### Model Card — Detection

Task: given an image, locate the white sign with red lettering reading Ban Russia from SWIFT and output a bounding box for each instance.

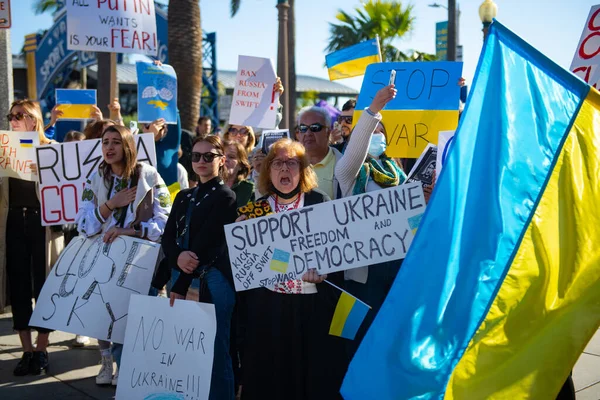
[229,56,279,129]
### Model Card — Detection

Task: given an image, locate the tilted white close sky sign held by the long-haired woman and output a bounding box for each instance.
[29,235,160,343]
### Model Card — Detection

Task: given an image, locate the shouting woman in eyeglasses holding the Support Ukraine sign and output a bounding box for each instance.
[239,139,347,400]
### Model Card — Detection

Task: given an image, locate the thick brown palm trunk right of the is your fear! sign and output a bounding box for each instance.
[168,0,202,131]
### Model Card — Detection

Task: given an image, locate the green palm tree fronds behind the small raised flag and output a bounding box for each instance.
[326,0,435,61]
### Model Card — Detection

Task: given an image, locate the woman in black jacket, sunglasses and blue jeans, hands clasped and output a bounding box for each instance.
[152,136,236,400]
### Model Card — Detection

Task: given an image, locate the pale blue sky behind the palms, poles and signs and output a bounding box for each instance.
[11,0,598,89]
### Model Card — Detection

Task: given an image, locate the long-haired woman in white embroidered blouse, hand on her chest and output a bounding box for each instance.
[76,125,171,385]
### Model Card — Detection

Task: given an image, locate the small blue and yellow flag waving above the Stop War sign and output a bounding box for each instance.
[325,38,381,81]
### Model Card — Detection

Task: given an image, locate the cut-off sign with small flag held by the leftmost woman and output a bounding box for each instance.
[0,131,40,181]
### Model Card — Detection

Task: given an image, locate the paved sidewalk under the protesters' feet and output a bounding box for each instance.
[0,314,600,400]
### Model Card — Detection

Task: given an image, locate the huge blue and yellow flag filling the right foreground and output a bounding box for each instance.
[342,22,600,400]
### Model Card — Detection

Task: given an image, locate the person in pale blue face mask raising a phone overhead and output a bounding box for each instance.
[335,85,406,356]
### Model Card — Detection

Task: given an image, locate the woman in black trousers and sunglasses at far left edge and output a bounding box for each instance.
[0,100,63,376]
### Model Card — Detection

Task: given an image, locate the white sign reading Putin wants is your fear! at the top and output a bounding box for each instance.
[66,0,158,56]
